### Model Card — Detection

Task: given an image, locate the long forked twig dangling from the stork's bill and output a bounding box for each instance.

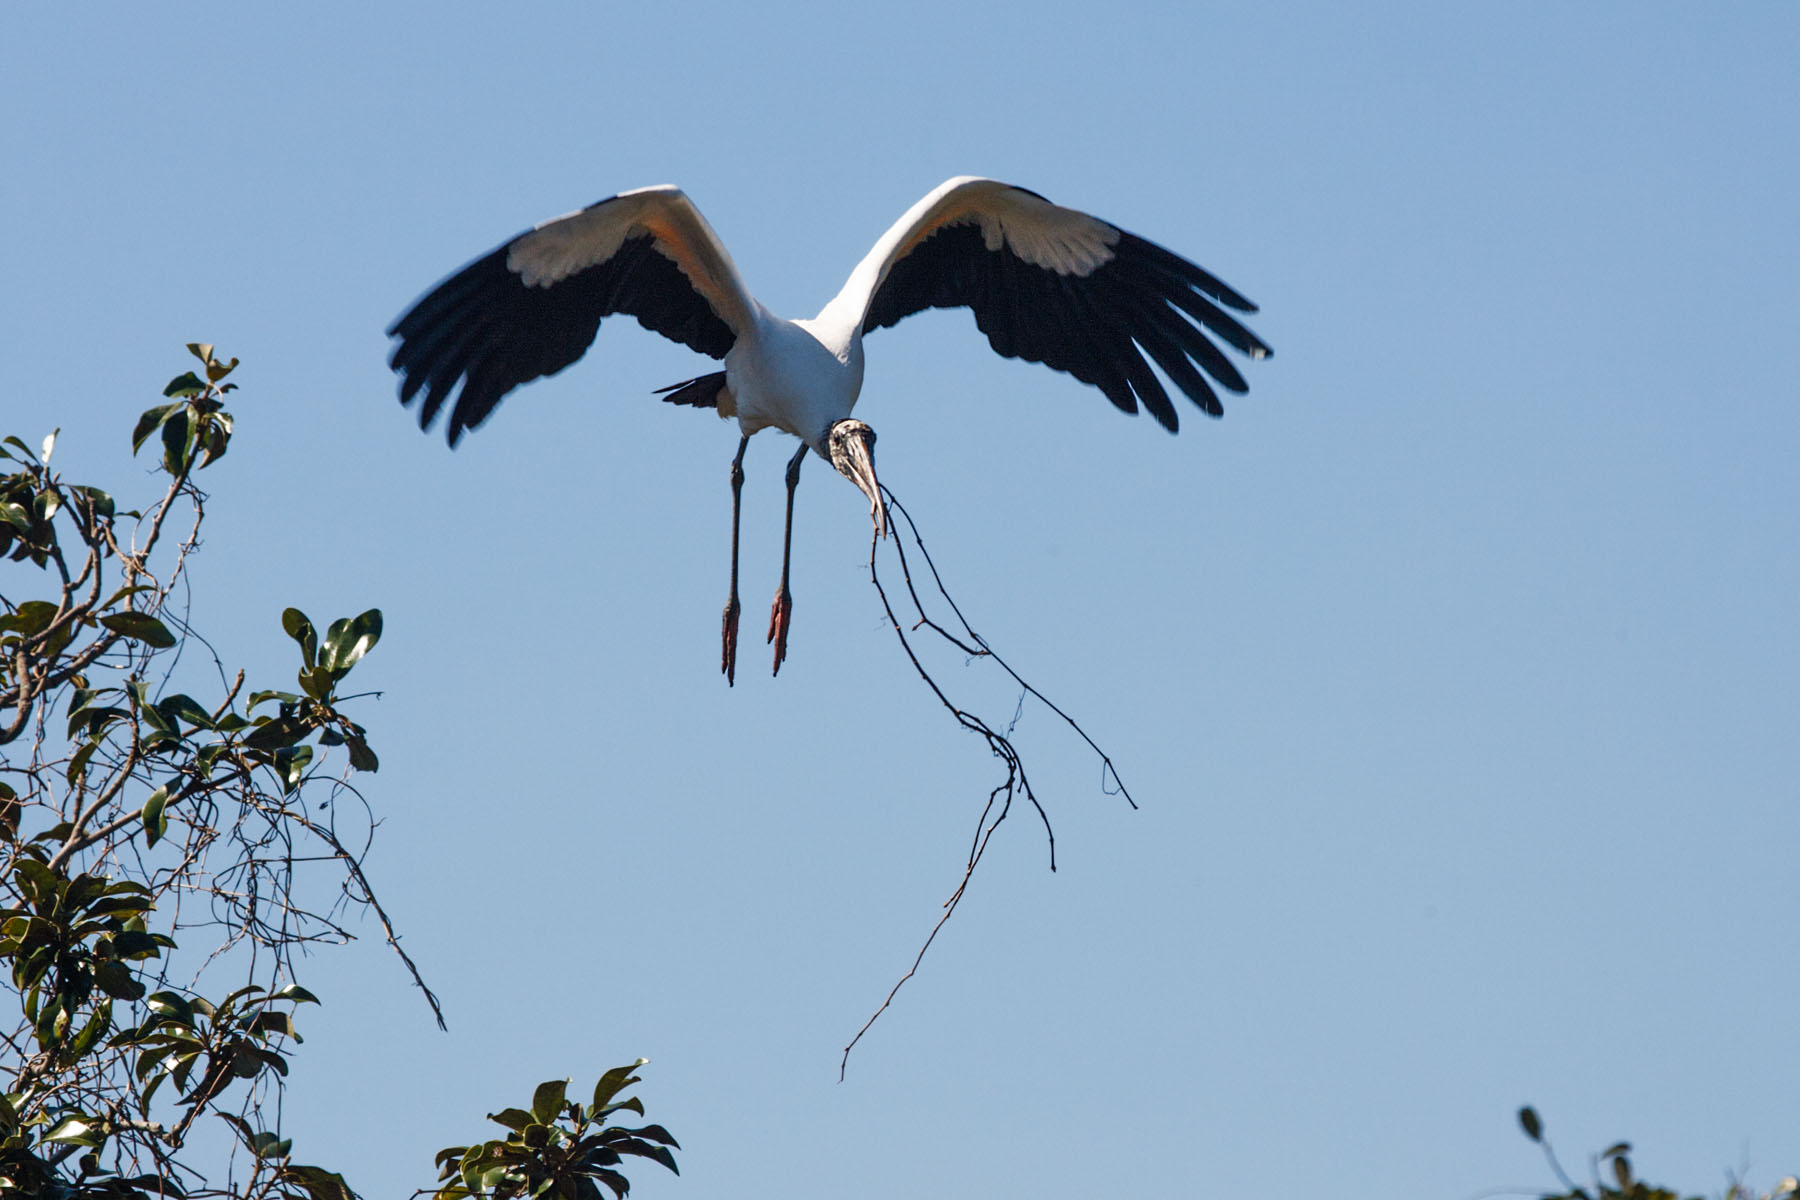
[837,486,1138,1083]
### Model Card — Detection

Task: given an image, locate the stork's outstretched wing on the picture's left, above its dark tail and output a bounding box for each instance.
[387,187,756,446]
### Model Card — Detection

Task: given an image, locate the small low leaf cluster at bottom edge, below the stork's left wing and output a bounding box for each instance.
[434,1058,680,1200]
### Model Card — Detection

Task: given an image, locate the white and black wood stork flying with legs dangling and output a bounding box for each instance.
[387,176,1269,684]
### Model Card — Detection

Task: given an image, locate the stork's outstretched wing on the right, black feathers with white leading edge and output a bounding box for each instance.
[832,176,1269,432]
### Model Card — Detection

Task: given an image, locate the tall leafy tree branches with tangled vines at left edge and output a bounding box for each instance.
[0,344,382,1200]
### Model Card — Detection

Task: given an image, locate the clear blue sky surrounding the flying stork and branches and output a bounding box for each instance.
[0,2,1800,1200]
